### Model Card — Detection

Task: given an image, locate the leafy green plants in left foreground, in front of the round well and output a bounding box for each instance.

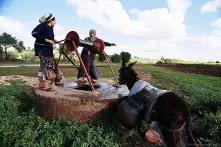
[0,81,147,147]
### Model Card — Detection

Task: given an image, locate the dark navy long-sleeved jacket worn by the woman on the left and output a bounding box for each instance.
[32,23,54,57]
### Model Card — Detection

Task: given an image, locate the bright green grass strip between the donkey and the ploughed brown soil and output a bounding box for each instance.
[144,66,221,105]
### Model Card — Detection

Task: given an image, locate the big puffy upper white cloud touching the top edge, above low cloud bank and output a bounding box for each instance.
[67,0,191,41]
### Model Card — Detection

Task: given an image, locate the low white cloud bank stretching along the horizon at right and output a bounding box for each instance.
[118,30,221,61]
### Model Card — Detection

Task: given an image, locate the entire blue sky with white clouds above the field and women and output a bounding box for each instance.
[0,0,221,61]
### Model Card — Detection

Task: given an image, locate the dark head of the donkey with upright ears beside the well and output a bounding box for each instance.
[119,62,140,90]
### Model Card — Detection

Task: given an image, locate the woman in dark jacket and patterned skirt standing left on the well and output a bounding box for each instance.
[32,13,61,90]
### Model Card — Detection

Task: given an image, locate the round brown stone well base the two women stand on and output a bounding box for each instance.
[34,80,129,123]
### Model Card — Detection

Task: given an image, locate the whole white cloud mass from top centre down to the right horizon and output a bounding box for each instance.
[65,0,221,60]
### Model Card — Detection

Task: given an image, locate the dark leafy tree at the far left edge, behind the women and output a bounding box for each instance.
[0,32,25,60]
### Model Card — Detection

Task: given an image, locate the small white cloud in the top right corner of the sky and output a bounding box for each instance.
[201,0,221,12]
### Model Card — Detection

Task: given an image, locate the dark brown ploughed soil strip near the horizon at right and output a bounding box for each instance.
[156,64,221,77]
